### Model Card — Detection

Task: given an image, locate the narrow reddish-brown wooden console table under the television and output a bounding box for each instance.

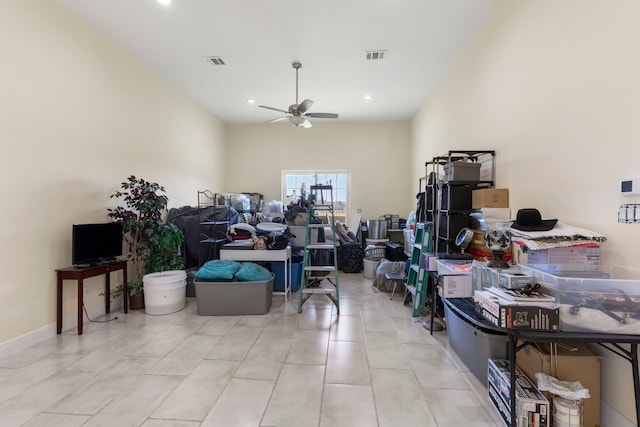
[56,261,129,335]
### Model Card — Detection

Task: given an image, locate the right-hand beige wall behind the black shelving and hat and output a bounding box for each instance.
[412,0,640,421]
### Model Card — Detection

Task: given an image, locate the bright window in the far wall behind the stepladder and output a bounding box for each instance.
[282,171,350,223]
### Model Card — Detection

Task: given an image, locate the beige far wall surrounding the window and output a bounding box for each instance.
[224,120,418,226]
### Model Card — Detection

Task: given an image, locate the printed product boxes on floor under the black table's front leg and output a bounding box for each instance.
[487,359,550,427]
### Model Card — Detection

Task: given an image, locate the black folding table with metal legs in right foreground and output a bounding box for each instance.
[446,298,640,426]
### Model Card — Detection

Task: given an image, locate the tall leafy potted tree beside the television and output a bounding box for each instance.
[108,175,184,310]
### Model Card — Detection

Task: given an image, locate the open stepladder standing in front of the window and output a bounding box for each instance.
[298,184,340,315]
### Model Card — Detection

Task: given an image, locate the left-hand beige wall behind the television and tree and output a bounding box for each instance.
[0,0,224,343]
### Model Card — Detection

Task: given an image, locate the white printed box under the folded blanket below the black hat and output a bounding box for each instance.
[511,244,600,271]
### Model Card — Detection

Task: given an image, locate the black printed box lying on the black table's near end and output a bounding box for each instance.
[473,291,560,331]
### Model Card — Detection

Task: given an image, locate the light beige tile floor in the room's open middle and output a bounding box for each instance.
[0,273,503,427]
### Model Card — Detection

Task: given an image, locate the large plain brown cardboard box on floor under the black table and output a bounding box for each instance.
[516,343,602,427]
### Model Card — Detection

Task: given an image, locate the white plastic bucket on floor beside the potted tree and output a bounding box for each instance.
[142,270,187,315]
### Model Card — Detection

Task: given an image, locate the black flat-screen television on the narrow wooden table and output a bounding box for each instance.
[71,222,122,266]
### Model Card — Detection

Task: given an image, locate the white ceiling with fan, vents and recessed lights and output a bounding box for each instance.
[58,0,496,123]
